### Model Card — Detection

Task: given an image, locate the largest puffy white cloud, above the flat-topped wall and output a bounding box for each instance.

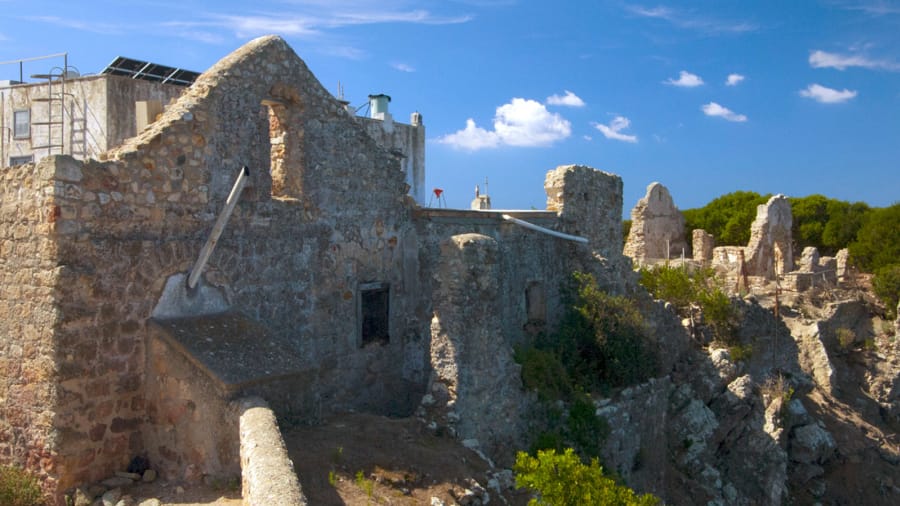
[437,98,572,151]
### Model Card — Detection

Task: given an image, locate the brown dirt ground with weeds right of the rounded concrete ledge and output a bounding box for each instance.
[284,414,529,506]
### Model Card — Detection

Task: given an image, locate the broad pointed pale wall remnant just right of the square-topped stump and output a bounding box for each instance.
[624,183,688,265]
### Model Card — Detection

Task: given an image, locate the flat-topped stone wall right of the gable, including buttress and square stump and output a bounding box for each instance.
[416,166,634,463]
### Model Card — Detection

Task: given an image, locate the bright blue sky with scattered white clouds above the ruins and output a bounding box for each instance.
[0,0,900,214]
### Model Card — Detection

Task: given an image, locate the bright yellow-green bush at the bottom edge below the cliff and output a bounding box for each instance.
[513,448,660,506]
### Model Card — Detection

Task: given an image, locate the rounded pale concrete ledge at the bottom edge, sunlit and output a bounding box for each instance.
[237,397,307,506]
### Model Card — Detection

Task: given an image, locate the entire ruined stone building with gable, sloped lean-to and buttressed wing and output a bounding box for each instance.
[0,36,630,498]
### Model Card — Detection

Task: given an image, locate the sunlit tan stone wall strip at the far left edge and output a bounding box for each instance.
[0,158,61,498]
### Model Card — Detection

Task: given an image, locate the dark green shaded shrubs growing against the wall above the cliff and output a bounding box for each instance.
[516,273,657,461]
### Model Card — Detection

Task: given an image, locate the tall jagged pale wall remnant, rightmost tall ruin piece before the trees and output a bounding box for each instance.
[746,195,794,279]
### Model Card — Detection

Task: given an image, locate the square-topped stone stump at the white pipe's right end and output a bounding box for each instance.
[544,165,622,258]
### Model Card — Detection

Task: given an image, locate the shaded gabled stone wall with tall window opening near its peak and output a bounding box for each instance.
[4,33,428,500]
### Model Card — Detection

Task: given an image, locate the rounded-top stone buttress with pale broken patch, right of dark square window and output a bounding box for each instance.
[431,234,527,460]
